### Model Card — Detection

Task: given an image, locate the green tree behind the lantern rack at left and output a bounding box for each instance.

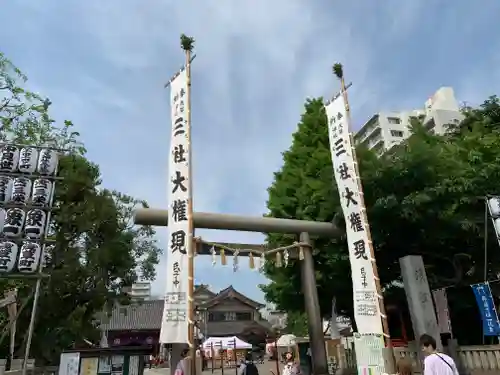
[0,53,161,364]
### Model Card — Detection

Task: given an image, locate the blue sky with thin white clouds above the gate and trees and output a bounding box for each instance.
[0,0,500,301]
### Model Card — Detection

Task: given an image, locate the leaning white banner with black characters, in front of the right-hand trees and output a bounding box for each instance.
[325,95,383,334]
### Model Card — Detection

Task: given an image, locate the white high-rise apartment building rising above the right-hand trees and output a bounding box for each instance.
[354,87,463,154]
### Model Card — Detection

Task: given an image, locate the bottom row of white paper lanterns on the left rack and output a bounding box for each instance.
[0,241,46,273]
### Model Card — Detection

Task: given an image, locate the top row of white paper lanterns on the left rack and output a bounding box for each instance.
[0,144,58,176]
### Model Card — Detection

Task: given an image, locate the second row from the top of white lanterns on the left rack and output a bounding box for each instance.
[0,176,53,207]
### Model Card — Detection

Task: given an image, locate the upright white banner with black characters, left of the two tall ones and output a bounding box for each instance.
[160,69,192,344]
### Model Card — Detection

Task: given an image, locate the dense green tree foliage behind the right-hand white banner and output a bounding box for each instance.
[262,97,500,344]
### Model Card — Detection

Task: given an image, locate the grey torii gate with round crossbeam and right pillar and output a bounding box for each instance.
[134,208,341,375]
